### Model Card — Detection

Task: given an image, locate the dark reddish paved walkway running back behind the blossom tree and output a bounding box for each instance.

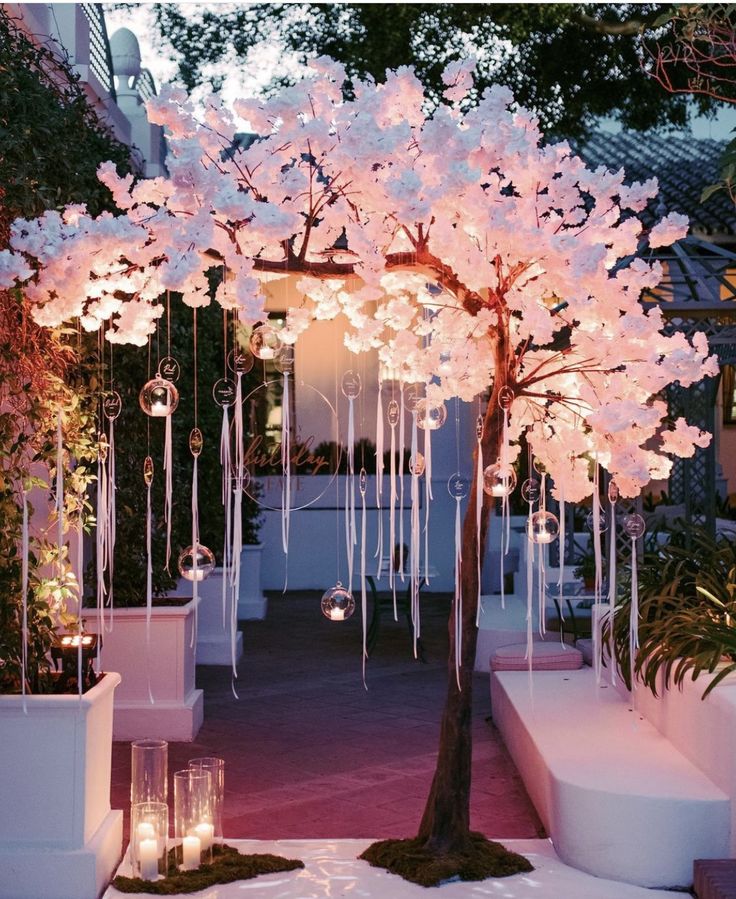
[112,593,543,840]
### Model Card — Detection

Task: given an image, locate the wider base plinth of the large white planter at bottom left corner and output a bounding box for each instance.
[0,811,123,899]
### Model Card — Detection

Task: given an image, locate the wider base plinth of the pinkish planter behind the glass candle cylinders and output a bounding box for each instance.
[113,690,204,743]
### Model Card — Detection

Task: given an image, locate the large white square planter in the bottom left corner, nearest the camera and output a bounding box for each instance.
[0,673,123,899]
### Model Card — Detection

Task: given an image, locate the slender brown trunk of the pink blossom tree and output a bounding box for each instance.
[418,338,508,854]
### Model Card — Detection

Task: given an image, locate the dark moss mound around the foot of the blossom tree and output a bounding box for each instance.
[360,833,534,887]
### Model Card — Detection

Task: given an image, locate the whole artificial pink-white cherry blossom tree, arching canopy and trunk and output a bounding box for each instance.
[0,59,717,884]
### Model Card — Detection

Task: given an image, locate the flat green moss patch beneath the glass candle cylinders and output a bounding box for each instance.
[112,846,304,896]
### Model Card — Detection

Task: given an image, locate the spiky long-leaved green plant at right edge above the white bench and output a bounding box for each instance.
[603,524,736,698]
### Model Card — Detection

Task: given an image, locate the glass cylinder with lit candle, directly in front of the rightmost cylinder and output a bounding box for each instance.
[174,768,214,871]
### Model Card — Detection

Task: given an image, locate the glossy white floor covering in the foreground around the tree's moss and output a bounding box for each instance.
[103,840,682,899]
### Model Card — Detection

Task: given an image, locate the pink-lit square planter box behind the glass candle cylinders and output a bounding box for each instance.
[85,599,204,742]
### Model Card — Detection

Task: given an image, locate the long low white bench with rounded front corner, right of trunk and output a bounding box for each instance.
[491,668,730,887]
